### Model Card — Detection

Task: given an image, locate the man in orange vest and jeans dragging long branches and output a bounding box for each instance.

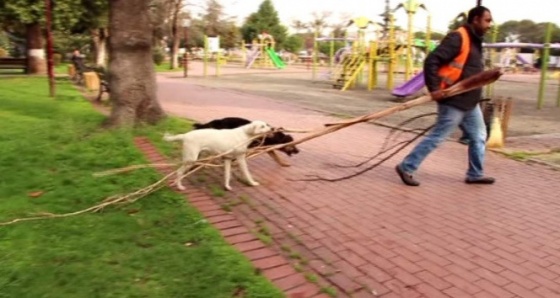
[396,6,494,186]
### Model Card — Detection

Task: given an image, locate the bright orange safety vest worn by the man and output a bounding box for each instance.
[438,27,471,89]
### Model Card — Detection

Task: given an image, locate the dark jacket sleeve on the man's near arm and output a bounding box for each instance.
[424,32,461,92]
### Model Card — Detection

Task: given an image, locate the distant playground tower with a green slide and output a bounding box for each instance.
[243,32,286,69]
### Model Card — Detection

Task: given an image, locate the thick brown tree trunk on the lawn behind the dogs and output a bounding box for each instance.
[107,0,165,126]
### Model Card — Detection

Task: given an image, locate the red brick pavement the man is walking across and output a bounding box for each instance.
[148,77,560,297]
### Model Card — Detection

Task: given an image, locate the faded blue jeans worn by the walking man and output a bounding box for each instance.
[400,104,486,179]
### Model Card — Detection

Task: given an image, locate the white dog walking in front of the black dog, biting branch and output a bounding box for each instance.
[163,121,272,190]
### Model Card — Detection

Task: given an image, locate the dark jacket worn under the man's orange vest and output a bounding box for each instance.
[424,25,484,111]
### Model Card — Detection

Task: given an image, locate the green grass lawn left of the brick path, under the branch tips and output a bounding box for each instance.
[0,77,283,298]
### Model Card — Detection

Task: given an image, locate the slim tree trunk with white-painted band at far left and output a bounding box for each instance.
[26,23,47,74]
